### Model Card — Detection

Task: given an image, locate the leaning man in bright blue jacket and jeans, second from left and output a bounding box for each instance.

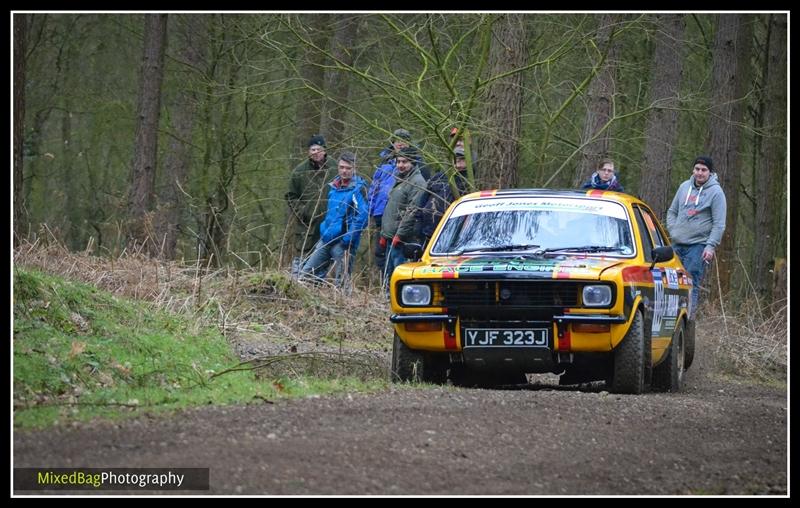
[302,151,367,287]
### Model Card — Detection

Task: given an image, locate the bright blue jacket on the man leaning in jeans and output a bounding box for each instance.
[319,175,369,252]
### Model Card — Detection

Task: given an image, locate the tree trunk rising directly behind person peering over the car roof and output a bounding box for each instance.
[572,14,618,187]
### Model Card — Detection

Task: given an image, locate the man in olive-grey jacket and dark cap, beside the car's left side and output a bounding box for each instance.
[376,146,426,288]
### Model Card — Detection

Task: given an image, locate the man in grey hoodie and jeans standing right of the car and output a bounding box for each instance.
[667,155,727,316]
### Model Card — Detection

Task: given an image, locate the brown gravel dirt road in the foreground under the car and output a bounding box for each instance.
[14,358,787,495]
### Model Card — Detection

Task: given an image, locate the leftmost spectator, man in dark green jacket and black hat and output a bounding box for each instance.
[285,134,336,273]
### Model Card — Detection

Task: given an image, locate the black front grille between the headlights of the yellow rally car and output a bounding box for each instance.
[440,280,583,309]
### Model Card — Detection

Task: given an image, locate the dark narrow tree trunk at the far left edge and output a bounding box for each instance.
[12,14,28,245]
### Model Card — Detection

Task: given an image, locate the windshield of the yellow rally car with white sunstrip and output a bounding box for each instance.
[431,197,634,256]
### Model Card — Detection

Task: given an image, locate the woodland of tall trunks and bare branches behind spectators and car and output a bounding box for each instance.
[12,12,788,308]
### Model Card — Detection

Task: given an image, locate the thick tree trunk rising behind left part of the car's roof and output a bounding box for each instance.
[478,14,527,189]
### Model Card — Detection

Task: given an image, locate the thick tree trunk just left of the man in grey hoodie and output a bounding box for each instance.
[639,14,686,221]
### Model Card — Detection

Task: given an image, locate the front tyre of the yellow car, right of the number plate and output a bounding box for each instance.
[609,311,650,393]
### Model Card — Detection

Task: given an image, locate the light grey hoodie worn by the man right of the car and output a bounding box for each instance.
[667,173,728,249]
